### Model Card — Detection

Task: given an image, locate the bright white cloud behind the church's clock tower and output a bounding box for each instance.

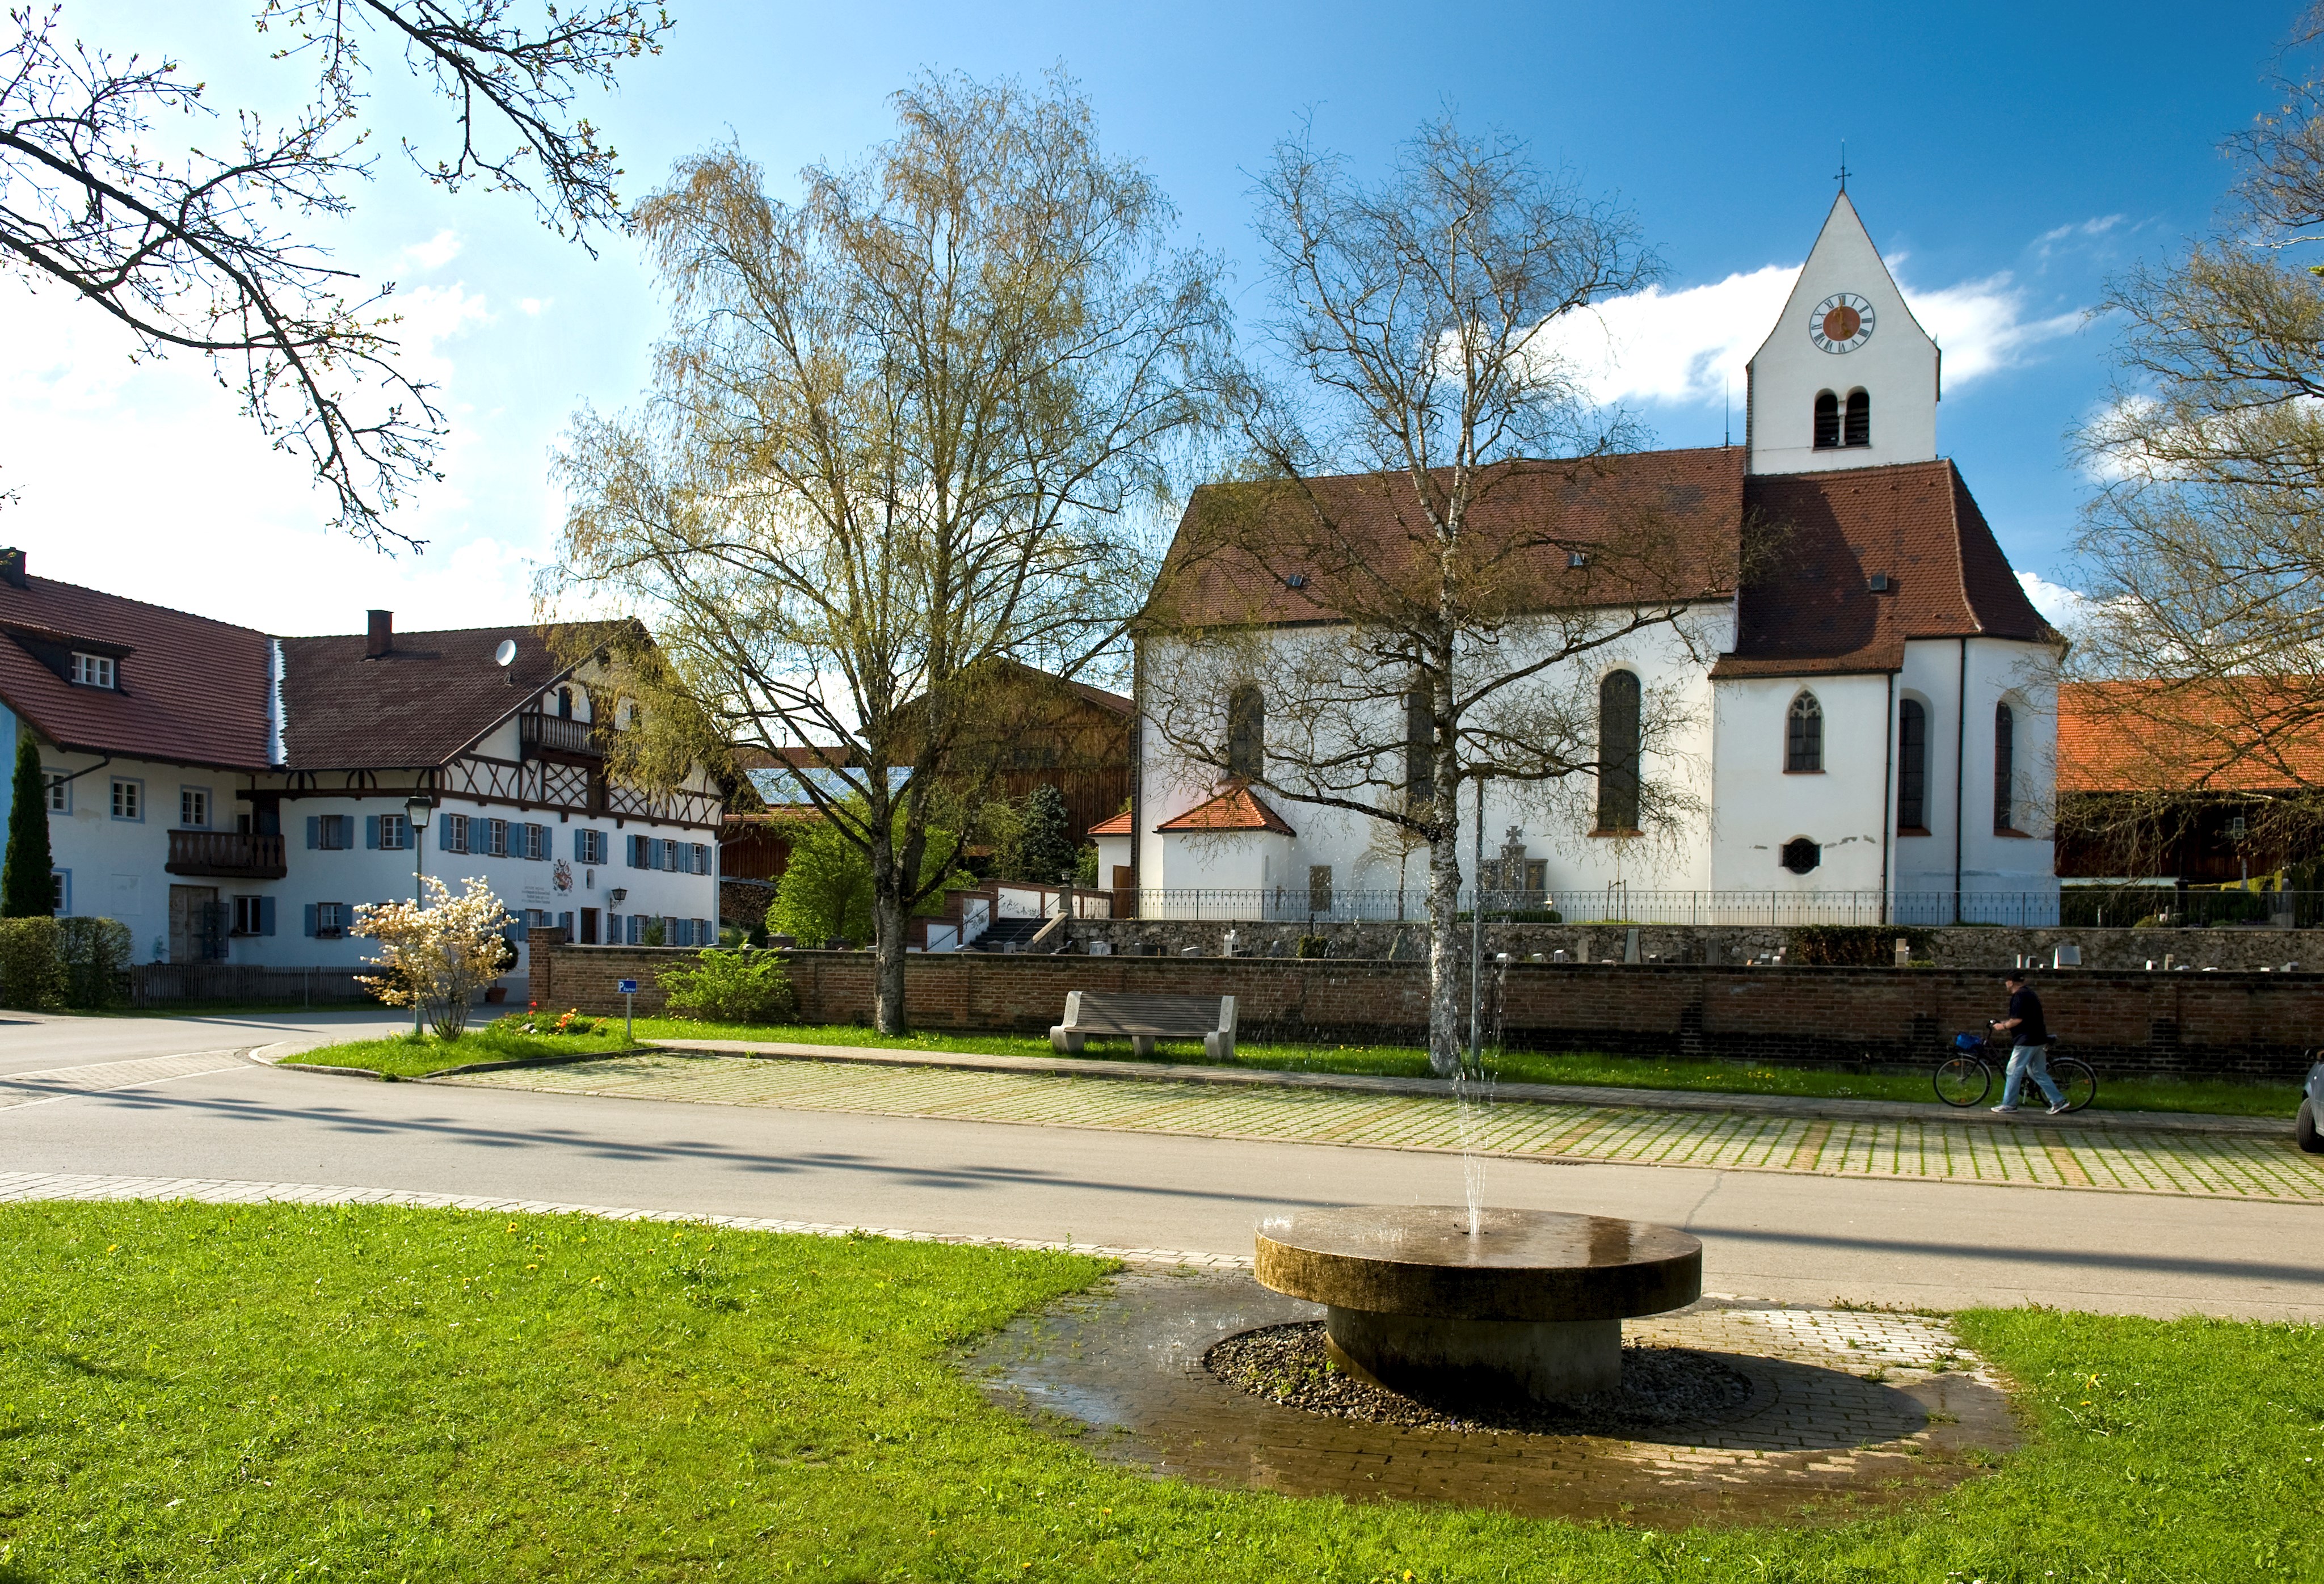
[1548,243,2082,406]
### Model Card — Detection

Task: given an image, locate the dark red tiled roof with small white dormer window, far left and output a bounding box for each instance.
[0,564,267,769]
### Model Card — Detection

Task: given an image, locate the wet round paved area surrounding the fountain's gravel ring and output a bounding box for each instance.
[967,1268,2017,1528]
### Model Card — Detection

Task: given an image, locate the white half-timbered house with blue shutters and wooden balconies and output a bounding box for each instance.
[0,550,721,975]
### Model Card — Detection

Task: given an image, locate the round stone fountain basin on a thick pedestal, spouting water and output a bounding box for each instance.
[1255,1206,1703,1405]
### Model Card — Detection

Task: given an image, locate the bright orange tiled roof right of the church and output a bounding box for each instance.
[2057,676,2324,792]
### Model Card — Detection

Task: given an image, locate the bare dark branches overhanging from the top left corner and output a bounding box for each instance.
[0,0,672,544]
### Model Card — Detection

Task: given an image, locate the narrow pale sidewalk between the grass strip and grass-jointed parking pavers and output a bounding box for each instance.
[646,1040,2298,1138]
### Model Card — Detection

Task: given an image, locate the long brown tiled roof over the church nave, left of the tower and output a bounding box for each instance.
[1153,446,1745,627]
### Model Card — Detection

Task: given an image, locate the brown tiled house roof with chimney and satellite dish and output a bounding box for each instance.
[279,627,572,771]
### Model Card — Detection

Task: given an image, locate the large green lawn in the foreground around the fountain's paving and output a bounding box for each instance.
[0,1203,2324,1584]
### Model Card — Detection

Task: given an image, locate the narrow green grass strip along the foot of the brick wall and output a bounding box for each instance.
[609,1017,2298,1119]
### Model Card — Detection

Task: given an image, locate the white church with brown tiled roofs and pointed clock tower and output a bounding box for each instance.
[1115,191,2059,924]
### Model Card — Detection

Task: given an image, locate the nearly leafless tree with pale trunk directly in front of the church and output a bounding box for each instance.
[1141,121,1736,1073]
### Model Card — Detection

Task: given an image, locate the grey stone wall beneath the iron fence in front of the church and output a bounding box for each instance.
[1069,920,2324,968]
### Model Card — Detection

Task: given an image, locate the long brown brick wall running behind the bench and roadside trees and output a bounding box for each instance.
[532,941,2324,1077]
